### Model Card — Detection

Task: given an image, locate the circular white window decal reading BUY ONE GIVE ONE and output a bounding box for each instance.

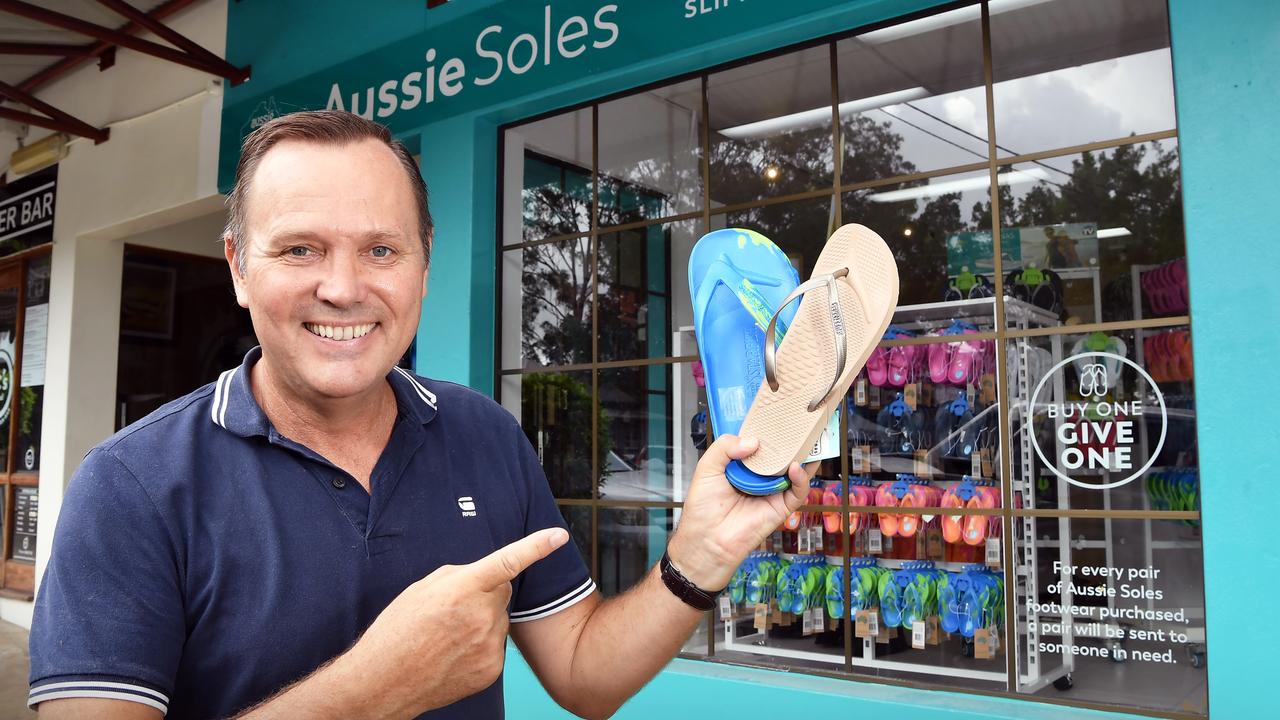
[1027,352,1169,489]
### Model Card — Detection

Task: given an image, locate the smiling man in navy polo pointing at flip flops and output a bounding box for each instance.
[29,111,809,719]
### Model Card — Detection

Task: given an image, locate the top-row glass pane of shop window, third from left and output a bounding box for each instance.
[707,45,835,209]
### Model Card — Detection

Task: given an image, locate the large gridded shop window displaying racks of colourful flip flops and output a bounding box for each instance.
[497,0,1207,716]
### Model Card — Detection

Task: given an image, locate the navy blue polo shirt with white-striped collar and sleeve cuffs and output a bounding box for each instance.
[28,348,595,719]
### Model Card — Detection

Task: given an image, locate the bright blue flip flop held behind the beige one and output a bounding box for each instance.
[689,228,800,495]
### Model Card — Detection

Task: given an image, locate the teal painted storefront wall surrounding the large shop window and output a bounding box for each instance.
[220,0,1280,720]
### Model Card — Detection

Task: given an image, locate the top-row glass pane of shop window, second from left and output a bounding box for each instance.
[599,79,703,227]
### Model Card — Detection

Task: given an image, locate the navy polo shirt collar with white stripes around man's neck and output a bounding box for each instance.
[210,346,436,437]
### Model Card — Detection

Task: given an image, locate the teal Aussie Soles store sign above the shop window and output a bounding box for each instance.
[219,0,933,190]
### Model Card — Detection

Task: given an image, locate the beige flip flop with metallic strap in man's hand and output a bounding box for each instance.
[739,224,897,477]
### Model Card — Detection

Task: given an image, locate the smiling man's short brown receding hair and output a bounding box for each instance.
[223,110,435,275]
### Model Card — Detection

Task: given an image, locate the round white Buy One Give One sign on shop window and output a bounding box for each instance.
[1028,352,1169,489]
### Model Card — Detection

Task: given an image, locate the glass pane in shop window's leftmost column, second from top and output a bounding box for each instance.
[502,237,593,369]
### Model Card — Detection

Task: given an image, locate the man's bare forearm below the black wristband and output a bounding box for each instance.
[572,566,705,716]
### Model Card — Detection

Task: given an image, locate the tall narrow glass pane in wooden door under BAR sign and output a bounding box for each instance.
[15,255,51,471]
